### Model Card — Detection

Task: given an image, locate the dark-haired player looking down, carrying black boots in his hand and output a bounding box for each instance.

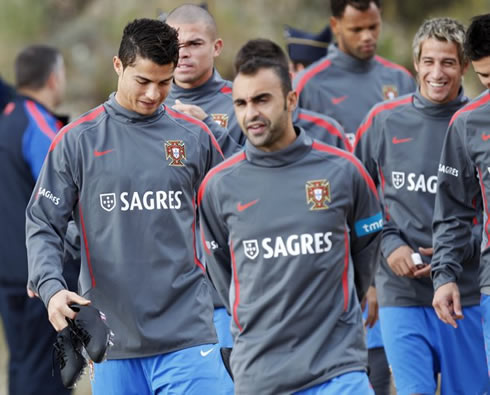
[26,19,228,395]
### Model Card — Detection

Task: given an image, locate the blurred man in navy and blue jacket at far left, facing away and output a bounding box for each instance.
[0,45,74,395]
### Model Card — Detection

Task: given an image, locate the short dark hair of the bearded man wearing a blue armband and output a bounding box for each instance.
[233,38,293,96]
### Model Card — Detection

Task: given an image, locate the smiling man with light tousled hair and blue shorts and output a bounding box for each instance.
[354,18,488,395]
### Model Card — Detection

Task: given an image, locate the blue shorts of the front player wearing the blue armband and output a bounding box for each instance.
[295,372,374,395]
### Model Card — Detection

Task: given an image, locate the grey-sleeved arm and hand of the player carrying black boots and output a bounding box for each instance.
[26,127,89,330]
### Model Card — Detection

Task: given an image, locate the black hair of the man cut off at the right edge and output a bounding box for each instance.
[464,14,490,60]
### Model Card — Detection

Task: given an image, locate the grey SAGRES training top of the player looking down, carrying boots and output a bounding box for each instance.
[26,94,222,359]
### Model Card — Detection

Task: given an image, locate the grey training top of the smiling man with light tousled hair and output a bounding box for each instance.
[354,91,479,306]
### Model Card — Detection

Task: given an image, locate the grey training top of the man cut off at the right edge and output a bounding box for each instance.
[432,90,490,294]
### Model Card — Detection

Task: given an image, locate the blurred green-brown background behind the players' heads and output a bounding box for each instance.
[0,0,490,117]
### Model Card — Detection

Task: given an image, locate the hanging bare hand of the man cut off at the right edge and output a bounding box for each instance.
[432,283,464,328]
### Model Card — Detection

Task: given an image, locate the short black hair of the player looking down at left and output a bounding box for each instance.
[118,18,179,68]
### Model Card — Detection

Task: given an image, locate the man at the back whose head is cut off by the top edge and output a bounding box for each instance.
[294,0,416,142]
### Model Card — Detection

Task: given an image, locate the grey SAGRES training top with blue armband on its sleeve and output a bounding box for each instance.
[198,129,383,395]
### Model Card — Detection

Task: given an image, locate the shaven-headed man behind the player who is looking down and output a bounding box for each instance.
[166,4,245,157]
